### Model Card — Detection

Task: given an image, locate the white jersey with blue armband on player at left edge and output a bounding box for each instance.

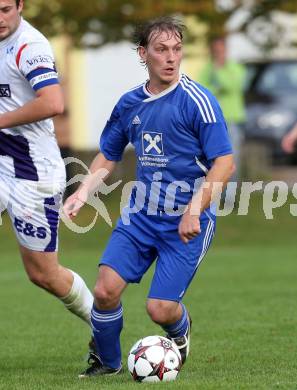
[0,19,65,181]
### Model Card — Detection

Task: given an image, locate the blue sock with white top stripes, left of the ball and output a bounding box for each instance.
[91,304,123,368]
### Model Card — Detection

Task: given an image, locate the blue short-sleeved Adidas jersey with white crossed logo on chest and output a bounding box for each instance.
[100,75,232,218]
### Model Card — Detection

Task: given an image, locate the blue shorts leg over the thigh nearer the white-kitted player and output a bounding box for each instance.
[99,228,157,283]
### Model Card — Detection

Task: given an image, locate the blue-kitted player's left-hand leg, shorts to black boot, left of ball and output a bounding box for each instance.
[80,222,156,377]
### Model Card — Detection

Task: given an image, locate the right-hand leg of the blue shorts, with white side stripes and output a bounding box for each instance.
[148,219,215,302]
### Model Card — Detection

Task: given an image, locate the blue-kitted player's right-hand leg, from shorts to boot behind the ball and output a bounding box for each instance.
[147,213,215,363]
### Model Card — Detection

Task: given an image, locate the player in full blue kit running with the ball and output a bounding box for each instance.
[64,17,234,377]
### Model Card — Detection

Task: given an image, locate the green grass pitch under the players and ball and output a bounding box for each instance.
[0,195,297,390]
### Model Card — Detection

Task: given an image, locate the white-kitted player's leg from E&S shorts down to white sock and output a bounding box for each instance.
[8,179,93,324]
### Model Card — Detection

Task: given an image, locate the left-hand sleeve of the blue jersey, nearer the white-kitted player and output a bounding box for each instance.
[100,106,129,161]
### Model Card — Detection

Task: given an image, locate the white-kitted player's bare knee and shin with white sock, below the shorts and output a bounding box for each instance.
[20,245,93,325]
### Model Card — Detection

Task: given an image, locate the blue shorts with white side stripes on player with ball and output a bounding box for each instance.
[100,212,215,302]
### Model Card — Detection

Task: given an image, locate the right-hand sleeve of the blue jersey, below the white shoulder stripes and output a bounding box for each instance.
[195,96,233,161]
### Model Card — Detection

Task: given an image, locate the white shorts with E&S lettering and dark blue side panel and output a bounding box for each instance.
[0,175,65,252]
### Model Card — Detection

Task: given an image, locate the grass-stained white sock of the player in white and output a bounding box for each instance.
[60,270,94,326]
